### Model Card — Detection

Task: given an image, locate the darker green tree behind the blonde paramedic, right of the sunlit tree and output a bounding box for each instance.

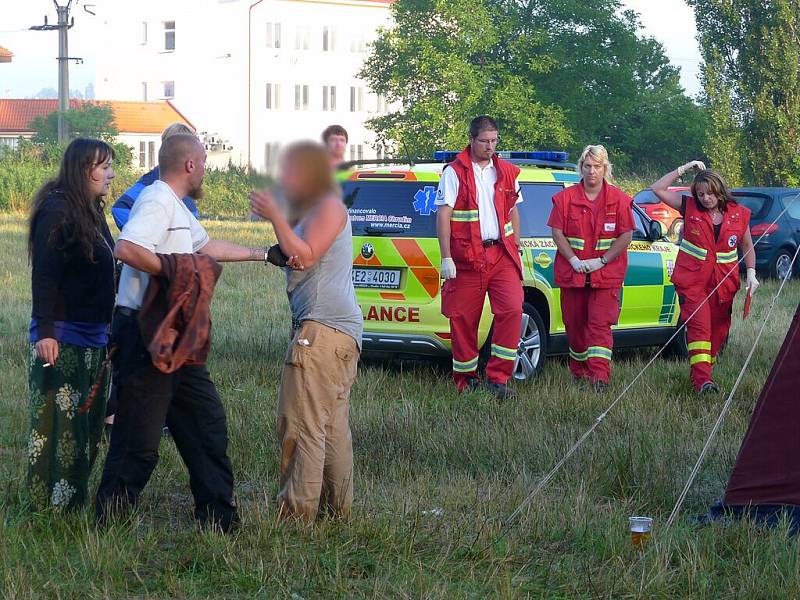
[517,0,707,171]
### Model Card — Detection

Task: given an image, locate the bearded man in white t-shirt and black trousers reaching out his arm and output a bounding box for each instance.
[96,134,266,531]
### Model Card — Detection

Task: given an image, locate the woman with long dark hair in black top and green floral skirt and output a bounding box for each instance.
[28,139,114,510]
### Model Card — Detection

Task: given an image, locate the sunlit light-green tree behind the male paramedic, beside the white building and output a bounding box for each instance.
[361,0,570,154]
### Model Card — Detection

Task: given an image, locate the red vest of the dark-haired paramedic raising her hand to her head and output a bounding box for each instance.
[672,196,750,302]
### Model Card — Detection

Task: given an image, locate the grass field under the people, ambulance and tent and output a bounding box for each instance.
[0,216,800,599]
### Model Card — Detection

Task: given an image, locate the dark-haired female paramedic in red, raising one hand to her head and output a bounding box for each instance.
[652,161,759,393]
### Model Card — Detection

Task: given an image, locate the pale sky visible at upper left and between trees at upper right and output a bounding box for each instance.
[0,0,700,98]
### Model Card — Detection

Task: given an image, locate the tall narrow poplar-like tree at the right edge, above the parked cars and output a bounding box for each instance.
[689,0,800,185]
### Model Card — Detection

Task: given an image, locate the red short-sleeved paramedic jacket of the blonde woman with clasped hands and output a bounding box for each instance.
[553,181,633,288]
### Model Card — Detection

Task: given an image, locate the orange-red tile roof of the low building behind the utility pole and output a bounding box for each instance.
[0,99,194,134]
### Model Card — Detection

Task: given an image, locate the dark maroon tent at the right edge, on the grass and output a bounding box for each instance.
[708,305,800,533]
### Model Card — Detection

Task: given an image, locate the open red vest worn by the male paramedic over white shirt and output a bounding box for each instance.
[446,147,522,279]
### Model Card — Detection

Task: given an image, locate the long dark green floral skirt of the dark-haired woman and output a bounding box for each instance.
[28,343,110,510]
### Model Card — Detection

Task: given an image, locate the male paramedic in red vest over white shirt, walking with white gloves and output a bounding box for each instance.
[436,115,523,399]
